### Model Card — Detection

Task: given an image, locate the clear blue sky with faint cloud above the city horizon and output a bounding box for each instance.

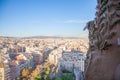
[0,0,97,37]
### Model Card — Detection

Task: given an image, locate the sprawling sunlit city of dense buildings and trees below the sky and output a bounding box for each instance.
[0,37,88,80]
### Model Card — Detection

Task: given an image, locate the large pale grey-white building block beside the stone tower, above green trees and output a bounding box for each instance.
[58,52,85,72]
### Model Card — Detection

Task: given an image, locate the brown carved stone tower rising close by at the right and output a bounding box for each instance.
[85,0,120,80]
